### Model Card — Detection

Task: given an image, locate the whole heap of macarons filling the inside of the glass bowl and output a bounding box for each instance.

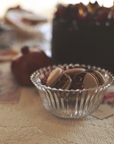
[46,68,105,90]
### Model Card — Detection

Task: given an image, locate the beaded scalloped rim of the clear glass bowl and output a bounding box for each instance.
[30,63,114,92]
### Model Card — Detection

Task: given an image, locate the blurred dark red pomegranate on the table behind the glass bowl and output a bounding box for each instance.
[11,46,52,86]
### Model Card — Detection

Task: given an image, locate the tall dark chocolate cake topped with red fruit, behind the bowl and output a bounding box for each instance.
[52,2,114,74]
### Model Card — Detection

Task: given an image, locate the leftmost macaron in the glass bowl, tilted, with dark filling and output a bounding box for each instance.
[46,68,72,89]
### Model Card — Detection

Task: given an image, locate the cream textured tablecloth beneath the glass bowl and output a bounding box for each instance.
[0,64,114,144]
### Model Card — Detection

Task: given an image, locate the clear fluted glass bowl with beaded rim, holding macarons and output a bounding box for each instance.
[30,64,113,118]
